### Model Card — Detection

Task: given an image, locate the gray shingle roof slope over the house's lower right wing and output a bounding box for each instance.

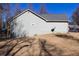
[40,14,67,22]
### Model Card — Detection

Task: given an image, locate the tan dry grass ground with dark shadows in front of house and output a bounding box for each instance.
[0,33,79,56]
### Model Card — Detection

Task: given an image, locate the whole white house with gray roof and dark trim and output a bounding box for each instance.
[11,10,68,37]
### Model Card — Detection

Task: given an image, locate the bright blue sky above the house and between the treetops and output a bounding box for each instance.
[11,3,79,19]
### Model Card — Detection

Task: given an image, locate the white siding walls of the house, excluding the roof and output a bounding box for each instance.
[12,11,68,37]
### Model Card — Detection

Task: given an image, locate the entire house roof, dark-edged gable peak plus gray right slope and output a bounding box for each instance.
[10,9,67,22]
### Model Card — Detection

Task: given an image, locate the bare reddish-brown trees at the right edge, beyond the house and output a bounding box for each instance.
[71,6,79,32]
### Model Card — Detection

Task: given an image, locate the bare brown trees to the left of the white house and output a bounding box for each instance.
[0,3,21,36]
